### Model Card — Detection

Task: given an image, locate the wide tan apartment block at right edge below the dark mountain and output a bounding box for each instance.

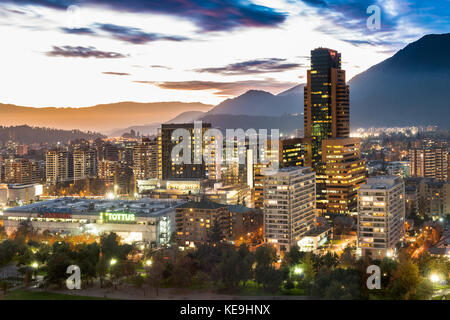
[409,147,448,181]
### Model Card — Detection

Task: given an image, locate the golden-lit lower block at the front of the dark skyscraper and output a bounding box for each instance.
[317,138,366,214]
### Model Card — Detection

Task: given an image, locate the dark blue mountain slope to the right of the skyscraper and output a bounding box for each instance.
[349,33,450,128]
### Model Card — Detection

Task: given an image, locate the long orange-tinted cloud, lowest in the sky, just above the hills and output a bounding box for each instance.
[134,78,297,97]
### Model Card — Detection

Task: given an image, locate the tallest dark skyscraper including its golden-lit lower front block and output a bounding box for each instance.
[303,48,365,213]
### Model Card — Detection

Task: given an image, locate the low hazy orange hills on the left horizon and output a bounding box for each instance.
[0,102,213,132]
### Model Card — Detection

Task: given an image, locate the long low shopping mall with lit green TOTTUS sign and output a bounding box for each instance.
[0,198,185,246]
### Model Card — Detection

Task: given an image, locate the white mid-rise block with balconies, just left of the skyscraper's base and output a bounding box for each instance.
[264,167,316,253]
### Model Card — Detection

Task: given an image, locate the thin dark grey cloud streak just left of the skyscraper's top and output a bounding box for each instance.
[195,58,302,75]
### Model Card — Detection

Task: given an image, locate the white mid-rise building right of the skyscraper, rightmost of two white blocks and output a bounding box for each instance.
[357,176,405,259]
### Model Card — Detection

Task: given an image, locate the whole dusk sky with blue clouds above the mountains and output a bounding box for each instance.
[0,0,450,107]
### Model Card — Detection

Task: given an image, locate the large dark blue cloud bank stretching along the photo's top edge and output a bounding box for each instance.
[5,0,287,31]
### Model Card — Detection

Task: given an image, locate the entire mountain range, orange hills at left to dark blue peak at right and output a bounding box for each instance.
[0,34,450,136]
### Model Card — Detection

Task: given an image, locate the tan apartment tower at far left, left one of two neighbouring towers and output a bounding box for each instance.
[46,150,69,184]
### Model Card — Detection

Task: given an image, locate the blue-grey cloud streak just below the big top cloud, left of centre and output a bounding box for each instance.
[96,24,189,44]
